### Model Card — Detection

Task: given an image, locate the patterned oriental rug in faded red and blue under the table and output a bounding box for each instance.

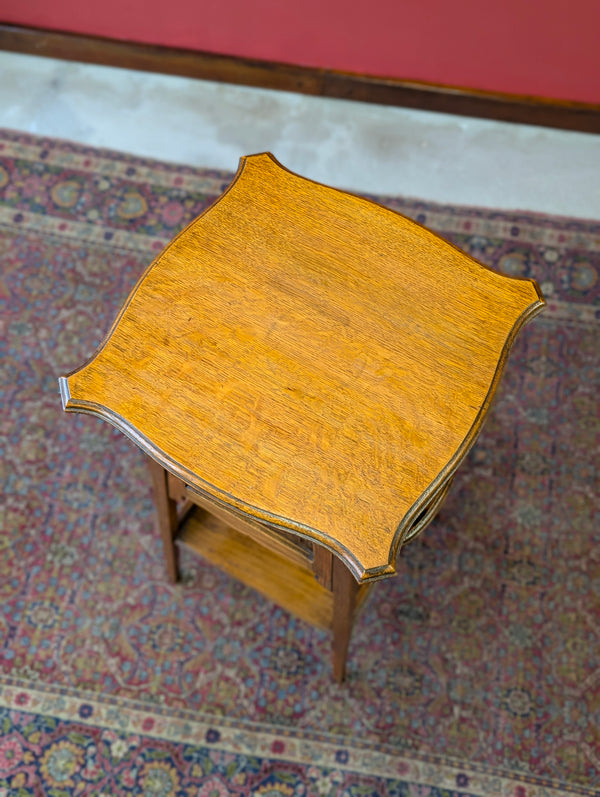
[0,131,600,797]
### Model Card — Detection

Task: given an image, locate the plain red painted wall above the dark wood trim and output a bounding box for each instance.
[0,0,600,103]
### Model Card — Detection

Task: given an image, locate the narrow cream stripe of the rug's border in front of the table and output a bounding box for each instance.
[0,675,598,797]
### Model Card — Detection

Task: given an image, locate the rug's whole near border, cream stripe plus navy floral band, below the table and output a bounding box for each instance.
[0,683,594,797]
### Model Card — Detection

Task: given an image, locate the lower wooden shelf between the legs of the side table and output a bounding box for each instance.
[179,507,338,629]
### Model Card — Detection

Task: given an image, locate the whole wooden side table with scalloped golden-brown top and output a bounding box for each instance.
[60,154,544,680]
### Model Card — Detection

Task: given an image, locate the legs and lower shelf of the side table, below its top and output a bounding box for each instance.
[155,458,364,682]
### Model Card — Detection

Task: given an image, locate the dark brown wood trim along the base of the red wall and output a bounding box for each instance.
[0,23,600,133]
